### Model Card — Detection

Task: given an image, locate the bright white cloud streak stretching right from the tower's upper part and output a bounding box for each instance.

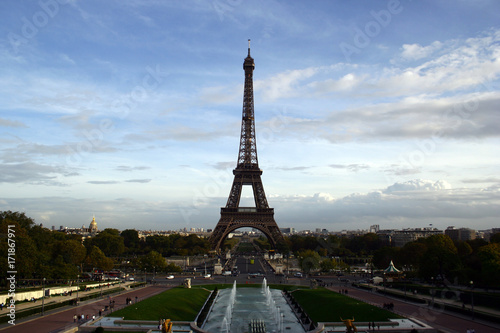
[256,30,500,101]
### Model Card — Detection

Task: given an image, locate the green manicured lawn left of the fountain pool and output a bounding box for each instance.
[109,288,210,321]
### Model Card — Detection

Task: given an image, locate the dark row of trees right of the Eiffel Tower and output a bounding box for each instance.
[255,233,500,288]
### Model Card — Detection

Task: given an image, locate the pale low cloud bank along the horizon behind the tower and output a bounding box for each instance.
[2,179,500,231]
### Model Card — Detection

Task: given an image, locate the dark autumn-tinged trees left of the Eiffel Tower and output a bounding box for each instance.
[0,211,205,286]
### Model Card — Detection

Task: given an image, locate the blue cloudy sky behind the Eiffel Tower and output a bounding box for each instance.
[0,0,500,231]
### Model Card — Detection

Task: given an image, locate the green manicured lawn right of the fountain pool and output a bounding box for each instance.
[292,288,401,322]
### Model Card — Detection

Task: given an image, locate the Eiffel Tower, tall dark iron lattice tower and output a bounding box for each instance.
[209,39,283,251]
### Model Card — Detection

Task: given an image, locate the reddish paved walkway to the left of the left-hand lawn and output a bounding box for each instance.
[0,285,168,333]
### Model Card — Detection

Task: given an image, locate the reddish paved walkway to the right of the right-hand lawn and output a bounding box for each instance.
[342,287,500,333]
